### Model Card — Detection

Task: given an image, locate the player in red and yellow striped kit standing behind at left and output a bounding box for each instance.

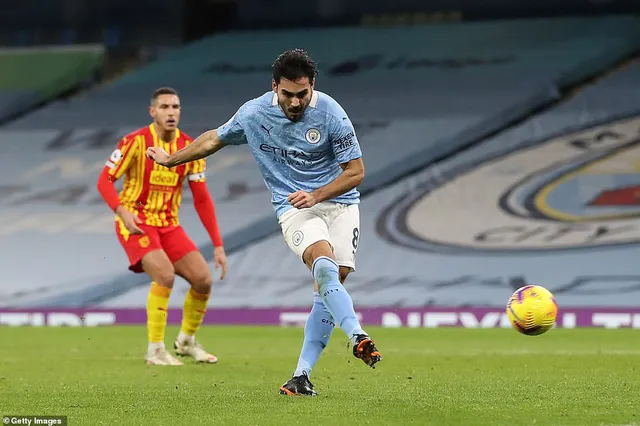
[97,87,227,365]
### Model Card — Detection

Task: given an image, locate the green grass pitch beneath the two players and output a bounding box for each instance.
[0,327,640,426]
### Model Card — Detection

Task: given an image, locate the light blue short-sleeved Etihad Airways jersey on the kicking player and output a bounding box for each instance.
[217,90,362,217]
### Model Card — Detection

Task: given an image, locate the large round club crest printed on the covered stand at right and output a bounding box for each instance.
[378,116,640,254]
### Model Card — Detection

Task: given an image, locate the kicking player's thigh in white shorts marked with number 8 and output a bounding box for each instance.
[329,204,360,272]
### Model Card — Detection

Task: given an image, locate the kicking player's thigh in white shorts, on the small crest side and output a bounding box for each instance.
[279,208,331,263]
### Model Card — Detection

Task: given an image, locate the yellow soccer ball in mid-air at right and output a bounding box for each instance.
[507,285,558,336]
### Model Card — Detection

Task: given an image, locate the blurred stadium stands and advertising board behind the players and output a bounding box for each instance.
[0,0,640,328]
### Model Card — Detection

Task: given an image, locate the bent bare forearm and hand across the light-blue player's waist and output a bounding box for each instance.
[289,157,364,209]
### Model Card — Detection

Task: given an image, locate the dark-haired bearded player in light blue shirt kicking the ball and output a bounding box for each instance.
[147,49,382,395]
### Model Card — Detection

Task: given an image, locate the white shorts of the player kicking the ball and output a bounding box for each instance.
[279,201,360,271]
